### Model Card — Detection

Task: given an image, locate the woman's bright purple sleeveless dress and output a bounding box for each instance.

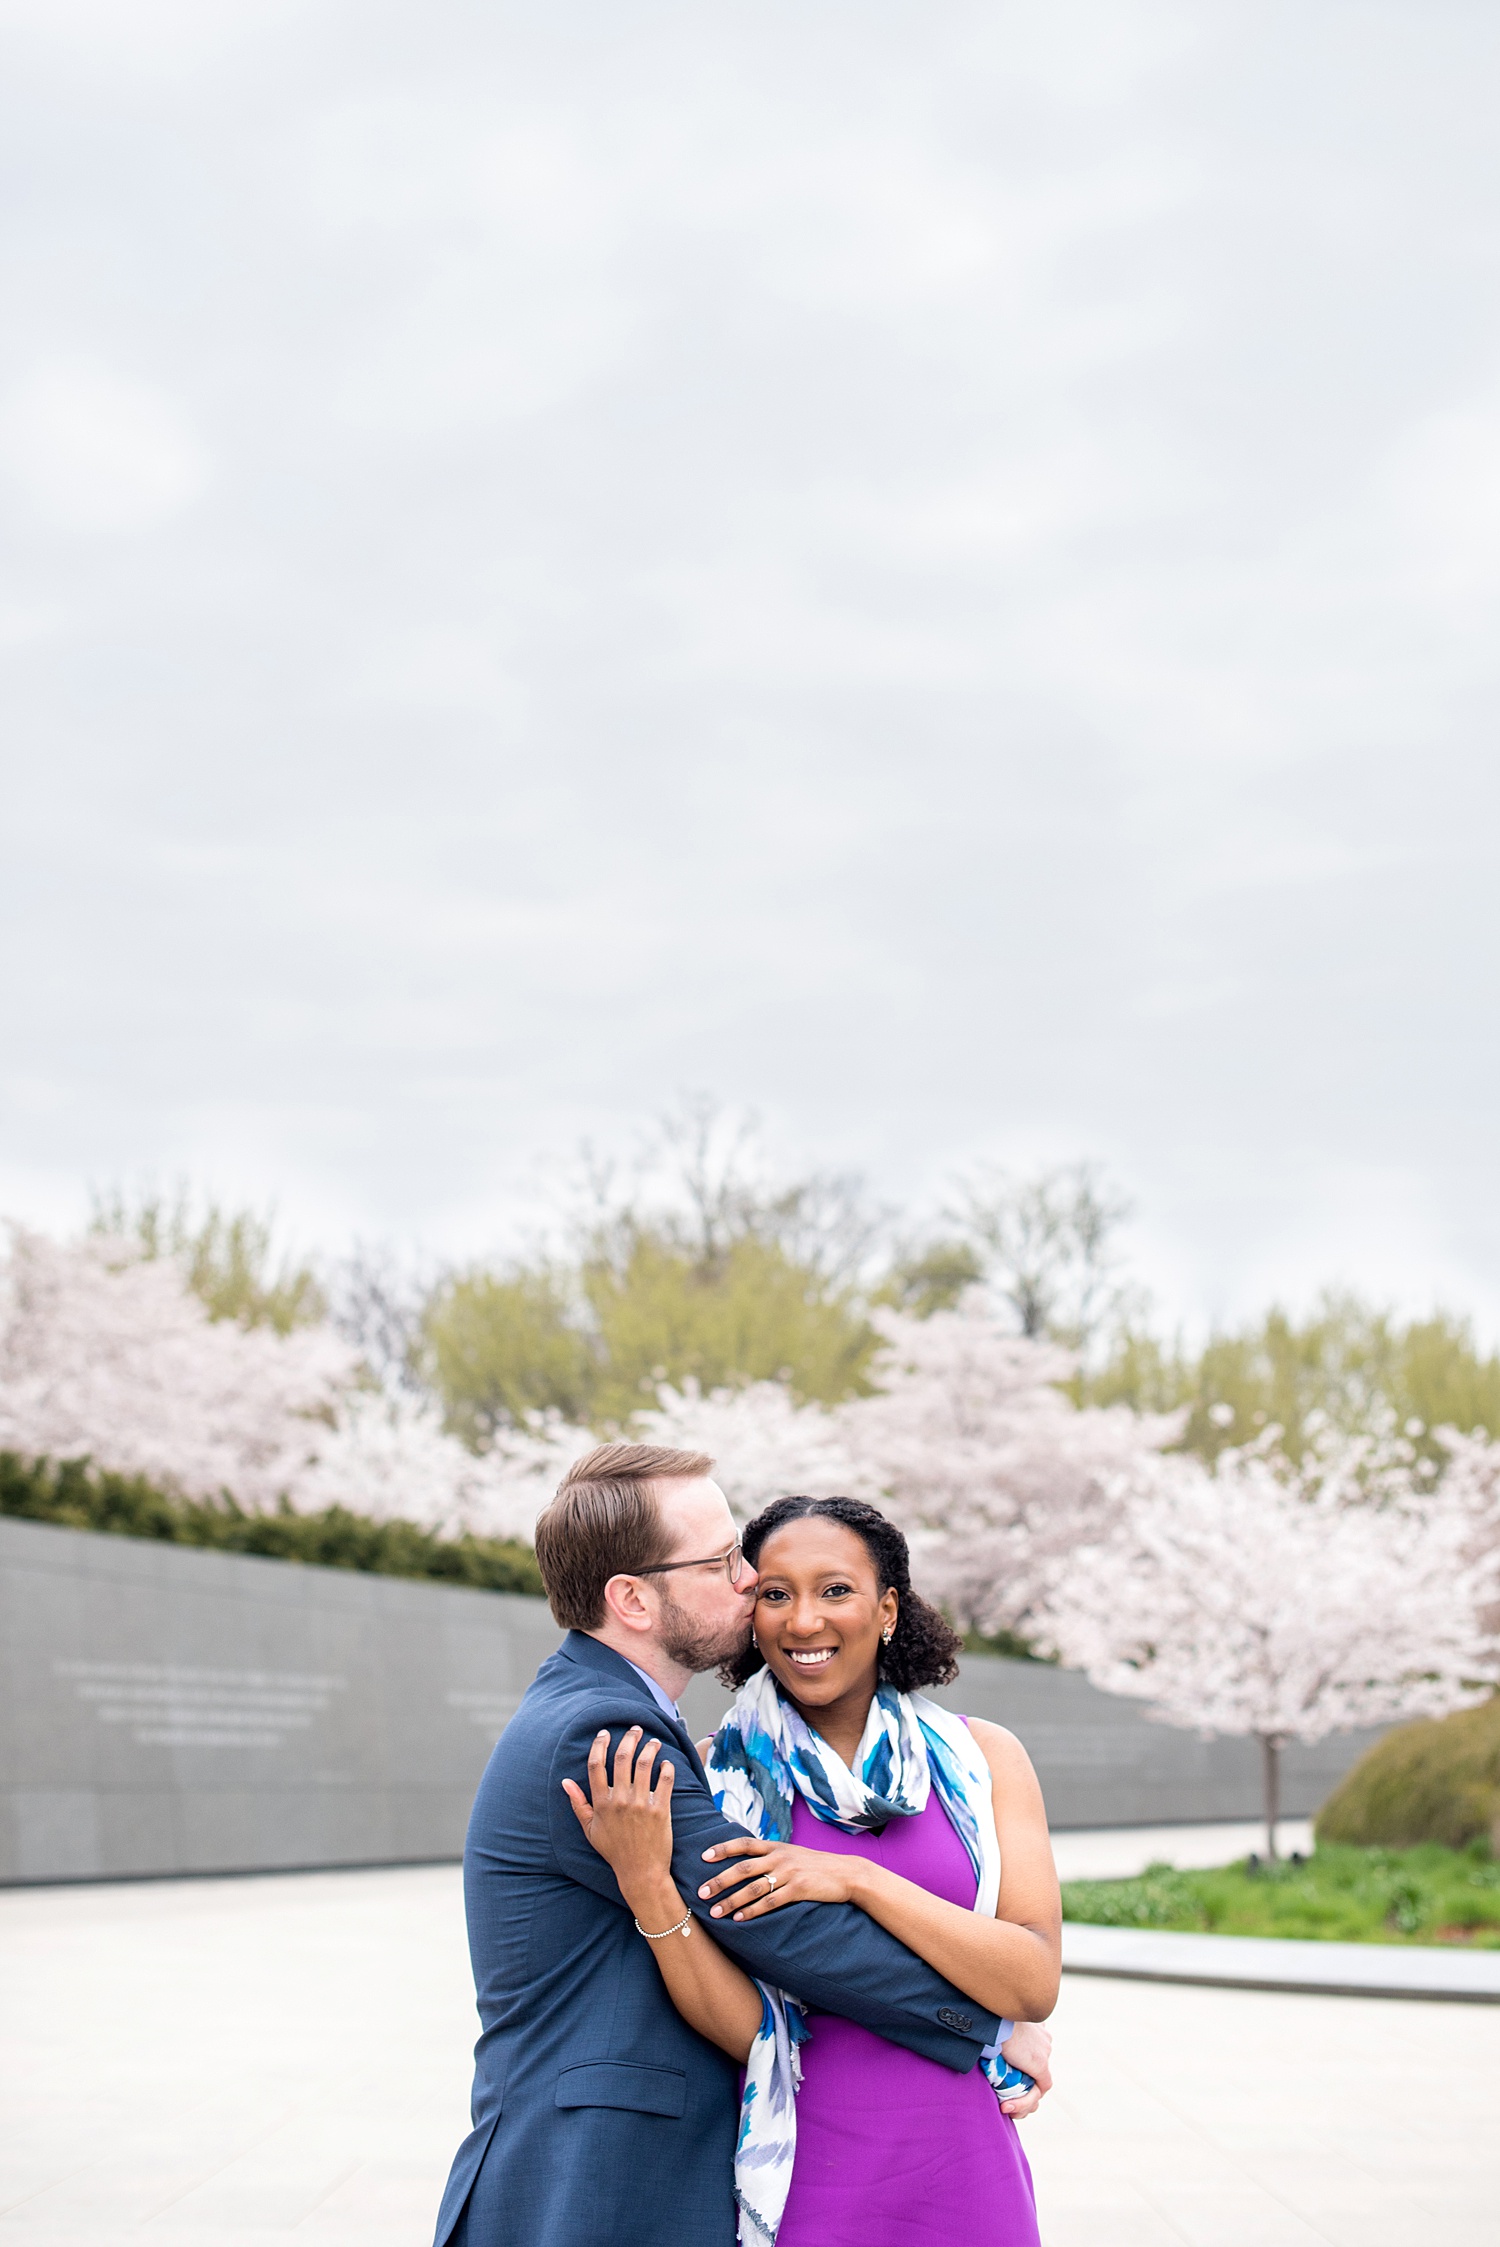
[777,1793,1037,2247]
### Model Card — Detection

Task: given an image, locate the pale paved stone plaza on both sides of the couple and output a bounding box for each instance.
[0,1867,1500,2247]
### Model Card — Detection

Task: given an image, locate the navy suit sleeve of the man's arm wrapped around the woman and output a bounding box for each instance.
[548,1692,999,2074]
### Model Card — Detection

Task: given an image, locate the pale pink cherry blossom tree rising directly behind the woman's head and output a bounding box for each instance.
[835,1290,1179,1634]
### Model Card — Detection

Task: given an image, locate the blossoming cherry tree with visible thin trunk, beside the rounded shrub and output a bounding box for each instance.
[1040,1443,1500,1856]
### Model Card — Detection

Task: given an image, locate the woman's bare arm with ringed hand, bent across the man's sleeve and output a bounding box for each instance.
[698,1719,1062,2020]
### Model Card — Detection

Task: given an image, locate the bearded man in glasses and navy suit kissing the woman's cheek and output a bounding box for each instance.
[433,1443,1037,2247]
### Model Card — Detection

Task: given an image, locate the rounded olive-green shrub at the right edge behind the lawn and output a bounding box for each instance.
[1318,1694,1500,1849]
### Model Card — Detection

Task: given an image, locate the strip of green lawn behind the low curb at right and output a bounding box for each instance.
[1062,1843,1500,1950]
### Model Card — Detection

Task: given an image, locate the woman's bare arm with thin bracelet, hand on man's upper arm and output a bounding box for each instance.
[564,1726,761,2063]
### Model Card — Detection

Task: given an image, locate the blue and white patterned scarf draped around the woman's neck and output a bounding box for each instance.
[705,1670,1031,2247]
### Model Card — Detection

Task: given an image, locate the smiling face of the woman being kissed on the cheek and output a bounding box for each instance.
[754,1514,898,1710]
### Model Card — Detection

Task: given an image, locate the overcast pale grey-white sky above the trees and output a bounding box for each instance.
[0,0,1500,1330]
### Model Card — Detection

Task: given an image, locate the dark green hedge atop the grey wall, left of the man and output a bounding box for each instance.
[0,1452,541,1595]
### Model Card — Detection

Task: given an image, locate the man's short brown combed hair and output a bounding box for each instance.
[537,1443,714,1631]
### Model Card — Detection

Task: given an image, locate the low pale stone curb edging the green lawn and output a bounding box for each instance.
[1062,1919,1500,2004]
